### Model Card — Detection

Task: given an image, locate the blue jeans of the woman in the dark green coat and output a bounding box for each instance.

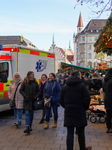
[25,110,34,126]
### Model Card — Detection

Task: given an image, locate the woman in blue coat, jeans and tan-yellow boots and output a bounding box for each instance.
[44,73,61,129]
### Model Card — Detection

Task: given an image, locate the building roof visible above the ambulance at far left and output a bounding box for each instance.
[0,36,36,48]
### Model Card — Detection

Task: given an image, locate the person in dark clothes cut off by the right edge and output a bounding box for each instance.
[104,69,112,133]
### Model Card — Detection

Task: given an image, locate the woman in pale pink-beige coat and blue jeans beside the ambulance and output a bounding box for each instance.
[8,72,23,127]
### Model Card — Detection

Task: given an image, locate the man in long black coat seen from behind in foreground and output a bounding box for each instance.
[59,70,91,150]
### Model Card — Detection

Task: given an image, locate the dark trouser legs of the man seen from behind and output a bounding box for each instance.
[66,127,85,150]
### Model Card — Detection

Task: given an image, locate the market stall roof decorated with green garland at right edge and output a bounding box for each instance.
[94,12,112,55]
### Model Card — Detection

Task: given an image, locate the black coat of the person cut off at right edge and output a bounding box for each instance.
[104,74,112,110]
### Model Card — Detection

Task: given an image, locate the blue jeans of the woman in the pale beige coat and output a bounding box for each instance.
[14,108,23,124]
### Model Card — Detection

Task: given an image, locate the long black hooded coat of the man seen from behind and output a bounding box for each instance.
[59,76,90,127]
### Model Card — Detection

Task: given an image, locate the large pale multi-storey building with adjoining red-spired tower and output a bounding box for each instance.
[73,13,111,68]
